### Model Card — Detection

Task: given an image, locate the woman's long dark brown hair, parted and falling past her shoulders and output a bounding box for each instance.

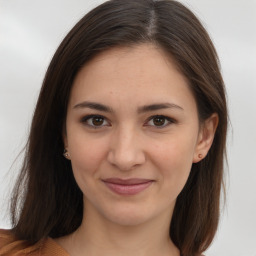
[11,0,227,256]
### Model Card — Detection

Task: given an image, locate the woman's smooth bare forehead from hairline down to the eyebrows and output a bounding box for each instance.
[70,44,195,112]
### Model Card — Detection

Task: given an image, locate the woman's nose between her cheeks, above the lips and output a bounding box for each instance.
[107,126,146,171]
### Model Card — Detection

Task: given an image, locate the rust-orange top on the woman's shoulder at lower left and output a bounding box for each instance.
[0,229,69,256]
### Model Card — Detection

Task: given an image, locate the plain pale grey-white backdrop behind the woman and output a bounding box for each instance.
[0,0,256,256]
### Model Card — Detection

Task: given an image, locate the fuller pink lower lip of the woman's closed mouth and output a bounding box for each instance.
[104,181,153,195]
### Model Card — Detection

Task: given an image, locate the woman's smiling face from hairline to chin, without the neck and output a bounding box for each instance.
[64,44,210,225]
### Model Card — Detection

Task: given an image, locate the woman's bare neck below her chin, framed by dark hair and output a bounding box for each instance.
[56,200,180,256]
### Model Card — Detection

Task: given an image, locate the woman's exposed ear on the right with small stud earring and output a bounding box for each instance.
[193,113,219,163]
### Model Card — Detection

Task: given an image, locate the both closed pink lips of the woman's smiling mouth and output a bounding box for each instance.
[103,178,153,195]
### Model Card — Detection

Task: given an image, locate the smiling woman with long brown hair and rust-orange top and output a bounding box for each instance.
[0,0,227,256]
